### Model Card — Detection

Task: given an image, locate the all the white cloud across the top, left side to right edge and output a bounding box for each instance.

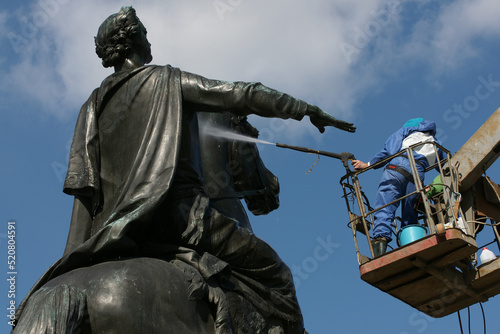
[0,0,500,137]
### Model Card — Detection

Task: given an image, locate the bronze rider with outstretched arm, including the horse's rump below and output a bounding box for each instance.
[13,7,355,334]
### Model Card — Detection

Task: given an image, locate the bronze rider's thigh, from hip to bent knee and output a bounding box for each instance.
[158,197,292,282]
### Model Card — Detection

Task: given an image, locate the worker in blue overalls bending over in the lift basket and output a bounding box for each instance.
[352,118,445,257]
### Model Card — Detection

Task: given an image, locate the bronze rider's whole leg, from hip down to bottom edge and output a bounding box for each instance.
[156,197,303,334]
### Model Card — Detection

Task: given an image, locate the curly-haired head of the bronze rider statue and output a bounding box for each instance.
[94,7,153,67]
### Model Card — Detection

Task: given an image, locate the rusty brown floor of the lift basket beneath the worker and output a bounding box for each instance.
[359,229,500,318]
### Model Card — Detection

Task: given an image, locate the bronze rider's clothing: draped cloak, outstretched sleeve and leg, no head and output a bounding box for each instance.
[17,66,307,332]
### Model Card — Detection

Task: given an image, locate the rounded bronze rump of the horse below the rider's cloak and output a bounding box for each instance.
[14,258,214,334]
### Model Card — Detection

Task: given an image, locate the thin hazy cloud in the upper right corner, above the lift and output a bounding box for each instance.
[376,0,500,79]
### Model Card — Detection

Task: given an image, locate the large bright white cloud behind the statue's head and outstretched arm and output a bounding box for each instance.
[0,0,382,121]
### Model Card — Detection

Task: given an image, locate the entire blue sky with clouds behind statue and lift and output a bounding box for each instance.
[0,0,500,334]
